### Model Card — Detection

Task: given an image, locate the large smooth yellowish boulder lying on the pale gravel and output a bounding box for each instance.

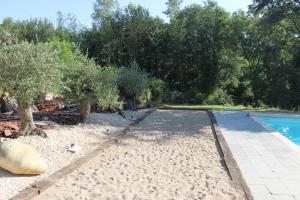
[0,140,47,175]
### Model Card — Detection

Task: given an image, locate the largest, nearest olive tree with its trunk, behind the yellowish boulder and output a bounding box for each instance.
[0,42,62,136]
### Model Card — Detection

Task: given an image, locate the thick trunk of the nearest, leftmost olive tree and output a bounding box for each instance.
[18,101,47,137]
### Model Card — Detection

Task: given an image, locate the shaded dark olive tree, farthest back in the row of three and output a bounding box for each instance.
[118,62,149,110]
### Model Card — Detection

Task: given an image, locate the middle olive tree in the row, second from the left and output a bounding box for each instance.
[64,52,121,123]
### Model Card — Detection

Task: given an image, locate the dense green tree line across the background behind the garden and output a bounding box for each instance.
[0,0,300,109]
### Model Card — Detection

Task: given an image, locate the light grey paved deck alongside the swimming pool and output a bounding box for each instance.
[214,111,300,200]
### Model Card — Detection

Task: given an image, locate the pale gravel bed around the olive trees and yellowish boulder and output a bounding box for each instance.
[0,111,144,200]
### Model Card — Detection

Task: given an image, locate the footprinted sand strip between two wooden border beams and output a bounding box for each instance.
[36,110,245,200]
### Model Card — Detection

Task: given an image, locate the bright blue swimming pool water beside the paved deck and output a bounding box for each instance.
[255,116,300,146]
